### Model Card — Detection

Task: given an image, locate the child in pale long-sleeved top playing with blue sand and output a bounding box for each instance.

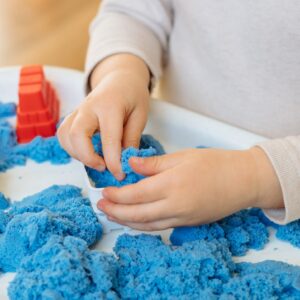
[58,0,300,230]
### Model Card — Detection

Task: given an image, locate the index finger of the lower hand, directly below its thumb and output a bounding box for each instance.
[102,174,167,204]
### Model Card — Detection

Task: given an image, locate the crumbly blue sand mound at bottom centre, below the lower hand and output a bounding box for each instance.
[114,234,235,299]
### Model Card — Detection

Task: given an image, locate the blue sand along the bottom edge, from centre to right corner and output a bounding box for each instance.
[115,234,300,300]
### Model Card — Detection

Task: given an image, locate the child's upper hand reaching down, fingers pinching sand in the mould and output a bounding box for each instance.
[57,54,150,180]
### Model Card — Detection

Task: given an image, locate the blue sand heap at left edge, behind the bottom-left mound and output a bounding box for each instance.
[0,185,102,272]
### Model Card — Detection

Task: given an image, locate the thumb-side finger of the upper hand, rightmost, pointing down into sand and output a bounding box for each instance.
[122,109,147,148]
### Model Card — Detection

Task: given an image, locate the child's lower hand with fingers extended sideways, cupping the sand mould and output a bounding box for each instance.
[98,148,283,230]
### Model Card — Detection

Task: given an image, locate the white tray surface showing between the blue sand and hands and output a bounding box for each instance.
[0,67,300,300]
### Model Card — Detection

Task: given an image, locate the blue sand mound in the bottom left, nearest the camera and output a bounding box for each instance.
[8,235,118,300]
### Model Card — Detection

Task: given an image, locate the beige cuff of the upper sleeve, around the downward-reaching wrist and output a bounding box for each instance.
[84,13,162,93]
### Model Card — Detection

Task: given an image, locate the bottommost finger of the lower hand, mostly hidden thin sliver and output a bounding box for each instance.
[108,217,178,231]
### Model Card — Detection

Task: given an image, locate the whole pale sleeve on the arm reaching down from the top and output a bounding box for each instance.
[85,0,172,92]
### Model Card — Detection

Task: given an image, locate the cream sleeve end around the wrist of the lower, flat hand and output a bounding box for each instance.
[258,136,300,224]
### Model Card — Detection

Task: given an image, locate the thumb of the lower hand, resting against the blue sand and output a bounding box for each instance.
[129,153,180,176]
